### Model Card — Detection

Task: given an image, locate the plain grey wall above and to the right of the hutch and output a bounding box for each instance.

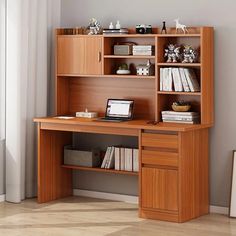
[61,0,236,206]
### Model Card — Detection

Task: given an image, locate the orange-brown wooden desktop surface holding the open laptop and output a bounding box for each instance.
[34,117,211,132]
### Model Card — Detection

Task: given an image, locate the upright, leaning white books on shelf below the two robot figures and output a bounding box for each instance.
[160,67,200,92]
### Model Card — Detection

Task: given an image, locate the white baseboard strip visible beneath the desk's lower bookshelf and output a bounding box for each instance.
[73,189,138,204]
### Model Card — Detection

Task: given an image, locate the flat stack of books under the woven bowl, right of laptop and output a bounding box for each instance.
[161,111,200,124]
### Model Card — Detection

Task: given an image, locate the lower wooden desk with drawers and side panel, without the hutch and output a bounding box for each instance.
[34,118,210,222]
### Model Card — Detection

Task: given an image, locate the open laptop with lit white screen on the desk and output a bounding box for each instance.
[97,99,134,122]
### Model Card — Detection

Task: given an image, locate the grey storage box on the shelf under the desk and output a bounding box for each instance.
[64,145,101,167]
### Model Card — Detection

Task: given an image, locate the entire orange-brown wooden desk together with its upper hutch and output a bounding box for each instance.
[35,27,214,222]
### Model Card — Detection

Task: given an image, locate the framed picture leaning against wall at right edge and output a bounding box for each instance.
[229,150,236,217]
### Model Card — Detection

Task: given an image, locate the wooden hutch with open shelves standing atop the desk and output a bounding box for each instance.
[56,27,214,124]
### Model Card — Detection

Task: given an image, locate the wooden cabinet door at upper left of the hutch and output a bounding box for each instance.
[57,36,102,75]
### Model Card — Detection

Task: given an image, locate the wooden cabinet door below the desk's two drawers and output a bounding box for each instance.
[141,167,178,211]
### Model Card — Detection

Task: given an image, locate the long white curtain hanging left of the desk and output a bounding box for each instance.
[6,0,60,203]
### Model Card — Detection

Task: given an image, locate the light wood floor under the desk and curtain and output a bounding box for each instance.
[0,197,236,236]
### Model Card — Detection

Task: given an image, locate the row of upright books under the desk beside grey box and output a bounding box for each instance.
[101,146,139,172]
